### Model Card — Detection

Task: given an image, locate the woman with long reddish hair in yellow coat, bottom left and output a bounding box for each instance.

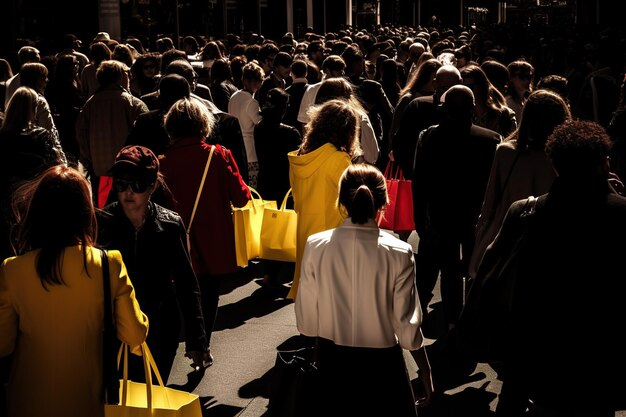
[0,165,148,417]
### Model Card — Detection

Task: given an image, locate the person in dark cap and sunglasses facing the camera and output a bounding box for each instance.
[98,145,213,381]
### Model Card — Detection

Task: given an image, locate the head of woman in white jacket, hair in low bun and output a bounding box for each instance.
[338,164,389,224]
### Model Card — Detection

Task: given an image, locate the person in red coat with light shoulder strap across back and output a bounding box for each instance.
[161,98,250,360]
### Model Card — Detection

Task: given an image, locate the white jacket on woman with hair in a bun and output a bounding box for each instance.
[295,218,423,350]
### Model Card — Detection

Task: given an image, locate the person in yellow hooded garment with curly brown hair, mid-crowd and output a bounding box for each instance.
[287,100,362,300]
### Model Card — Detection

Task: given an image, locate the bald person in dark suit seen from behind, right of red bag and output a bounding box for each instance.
[412,85,501,328]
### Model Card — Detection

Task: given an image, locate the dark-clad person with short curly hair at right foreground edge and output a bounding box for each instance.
[493,121,626,417]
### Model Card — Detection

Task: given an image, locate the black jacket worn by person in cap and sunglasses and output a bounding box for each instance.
[98,202,207,356]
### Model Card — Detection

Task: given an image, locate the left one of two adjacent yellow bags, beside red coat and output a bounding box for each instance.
[233,187,276,266]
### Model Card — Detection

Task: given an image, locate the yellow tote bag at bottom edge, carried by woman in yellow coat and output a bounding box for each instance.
[104,342,202,417]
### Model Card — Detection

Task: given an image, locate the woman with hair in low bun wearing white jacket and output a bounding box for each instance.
[295,164,433,417]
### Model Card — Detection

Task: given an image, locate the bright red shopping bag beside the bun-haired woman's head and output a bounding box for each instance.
[377,161,415,232]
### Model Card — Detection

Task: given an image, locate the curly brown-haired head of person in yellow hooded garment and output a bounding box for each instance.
[299,100,361,158]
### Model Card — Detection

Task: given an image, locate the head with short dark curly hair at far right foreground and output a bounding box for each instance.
[545,120,611,180]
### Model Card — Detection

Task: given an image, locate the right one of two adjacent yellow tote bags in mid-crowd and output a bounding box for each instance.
[260,189,298,262]
